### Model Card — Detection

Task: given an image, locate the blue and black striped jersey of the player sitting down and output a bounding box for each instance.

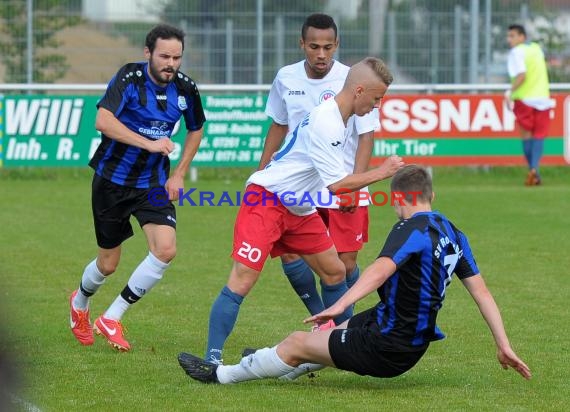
[377,212,479,350]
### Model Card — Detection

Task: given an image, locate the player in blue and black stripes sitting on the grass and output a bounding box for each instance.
[178,165,531,384]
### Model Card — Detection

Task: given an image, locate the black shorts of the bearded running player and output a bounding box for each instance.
[91,174,176,249]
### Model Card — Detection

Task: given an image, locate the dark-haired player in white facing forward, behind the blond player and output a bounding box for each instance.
[259,14,379,323]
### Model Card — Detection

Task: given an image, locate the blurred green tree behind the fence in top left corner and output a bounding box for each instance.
[0,0,81,83]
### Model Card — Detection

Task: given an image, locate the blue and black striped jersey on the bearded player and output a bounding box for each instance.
[89,63,206,188]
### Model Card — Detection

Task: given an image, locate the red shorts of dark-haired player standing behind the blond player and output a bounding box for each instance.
[318,206,368,253]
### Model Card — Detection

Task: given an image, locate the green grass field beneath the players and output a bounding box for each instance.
[0,168,570,411]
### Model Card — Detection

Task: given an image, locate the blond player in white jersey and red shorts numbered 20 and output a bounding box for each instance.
[199,57,403,363]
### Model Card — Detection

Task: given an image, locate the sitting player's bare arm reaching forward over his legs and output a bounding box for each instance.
[303,257,396,324]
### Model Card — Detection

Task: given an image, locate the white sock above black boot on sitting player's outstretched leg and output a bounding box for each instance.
[216,346,295,383]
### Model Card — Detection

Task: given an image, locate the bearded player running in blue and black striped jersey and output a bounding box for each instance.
[70,24,206,351]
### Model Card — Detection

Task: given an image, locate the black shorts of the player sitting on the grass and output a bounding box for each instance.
[329,308,427,378]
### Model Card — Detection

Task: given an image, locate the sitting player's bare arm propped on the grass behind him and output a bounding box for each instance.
[462,275,531,379]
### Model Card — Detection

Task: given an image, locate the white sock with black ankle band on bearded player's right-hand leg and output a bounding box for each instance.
[103,252,169,320]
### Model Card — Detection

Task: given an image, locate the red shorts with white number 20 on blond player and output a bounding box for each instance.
[232,184,334,272]
